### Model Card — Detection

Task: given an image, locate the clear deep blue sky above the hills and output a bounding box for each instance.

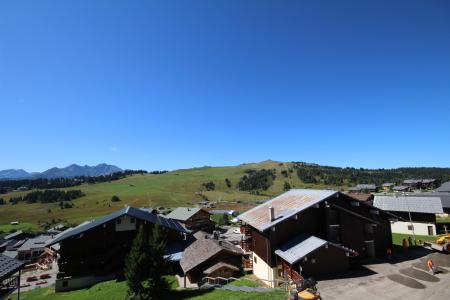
[0,0,450,171]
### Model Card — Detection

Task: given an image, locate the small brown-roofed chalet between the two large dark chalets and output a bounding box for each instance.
[180,235,243,287]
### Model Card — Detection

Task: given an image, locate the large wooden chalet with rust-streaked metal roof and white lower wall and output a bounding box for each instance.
[238,189,392,286]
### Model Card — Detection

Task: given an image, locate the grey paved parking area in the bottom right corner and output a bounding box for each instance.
[317,253,450,300]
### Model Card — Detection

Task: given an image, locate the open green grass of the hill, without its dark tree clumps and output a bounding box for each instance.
[0,161,342,224]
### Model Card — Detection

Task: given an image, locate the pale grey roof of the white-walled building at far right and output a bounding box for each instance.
[373,196,443,214]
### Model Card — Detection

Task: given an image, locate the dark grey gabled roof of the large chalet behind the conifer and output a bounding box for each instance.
[48,206,189,246]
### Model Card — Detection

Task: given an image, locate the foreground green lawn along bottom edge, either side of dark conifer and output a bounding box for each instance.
[21,276,286,300]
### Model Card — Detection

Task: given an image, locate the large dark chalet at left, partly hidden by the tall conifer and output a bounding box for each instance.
[47,207,189,291]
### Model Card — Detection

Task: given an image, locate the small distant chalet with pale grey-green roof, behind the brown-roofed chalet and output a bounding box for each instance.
[167,207,214,230]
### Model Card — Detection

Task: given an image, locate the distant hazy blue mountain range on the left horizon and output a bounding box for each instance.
[0,164,122,179]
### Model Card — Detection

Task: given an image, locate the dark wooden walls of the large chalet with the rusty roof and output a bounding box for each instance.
[242,193,392,278]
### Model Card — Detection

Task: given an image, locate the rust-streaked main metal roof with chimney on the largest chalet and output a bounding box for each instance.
[238,189,338,232]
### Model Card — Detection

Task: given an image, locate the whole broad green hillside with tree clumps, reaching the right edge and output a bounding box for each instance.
[0,160,450,232]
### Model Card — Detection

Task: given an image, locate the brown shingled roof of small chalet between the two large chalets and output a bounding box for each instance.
[180,238,243,273]
